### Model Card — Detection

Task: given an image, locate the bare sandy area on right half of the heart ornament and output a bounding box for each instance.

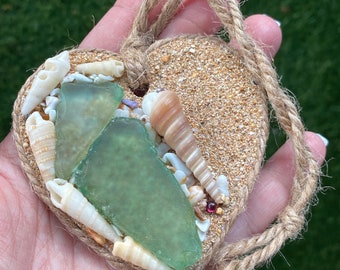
[149,37,268,268]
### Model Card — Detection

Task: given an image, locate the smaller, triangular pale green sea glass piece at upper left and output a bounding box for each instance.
[55,82,123,179]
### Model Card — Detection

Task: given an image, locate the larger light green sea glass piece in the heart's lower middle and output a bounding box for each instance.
[75,118,202,269]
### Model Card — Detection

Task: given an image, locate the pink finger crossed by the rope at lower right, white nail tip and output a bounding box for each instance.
[226,132,326,242]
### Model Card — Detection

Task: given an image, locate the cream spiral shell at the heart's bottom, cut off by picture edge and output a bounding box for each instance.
[112,236,170,270]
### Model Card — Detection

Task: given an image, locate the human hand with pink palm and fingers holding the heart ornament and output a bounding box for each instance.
[0,0,325,269]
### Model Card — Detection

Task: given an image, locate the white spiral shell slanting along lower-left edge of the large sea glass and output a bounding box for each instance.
[46,178,122,242]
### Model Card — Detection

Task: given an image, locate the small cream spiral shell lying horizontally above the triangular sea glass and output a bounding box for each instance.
[76,59,124,78]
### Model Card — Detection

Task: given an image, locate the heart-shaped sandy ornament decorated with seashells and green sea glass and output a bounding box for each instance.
[13,36,268,269]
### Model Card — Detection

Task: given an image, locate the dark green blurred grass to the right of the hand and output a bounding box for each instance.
[242,0,340,269]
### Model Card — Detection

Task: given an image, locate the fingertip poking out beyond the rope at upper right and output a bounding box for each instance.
[244,14,282,58]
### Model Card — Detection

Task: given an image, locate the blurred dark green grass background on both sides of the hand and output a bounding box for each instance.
[0,0,340,269]
